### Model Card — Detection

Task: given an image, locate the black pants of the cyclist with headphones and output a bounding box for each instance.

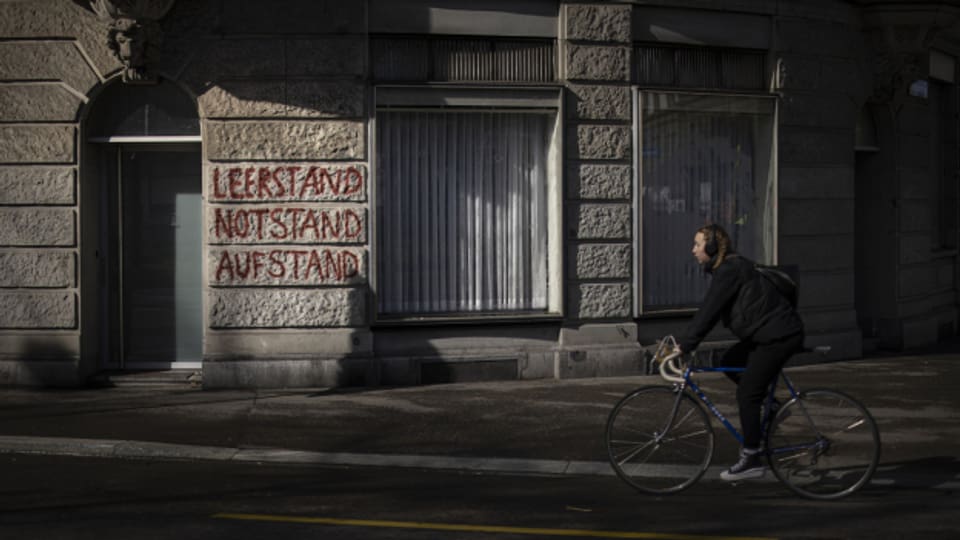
[721,333,803,448]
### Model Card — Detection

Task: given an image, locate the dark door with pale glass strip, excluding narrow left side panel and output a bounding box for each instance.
[118,145,203,368]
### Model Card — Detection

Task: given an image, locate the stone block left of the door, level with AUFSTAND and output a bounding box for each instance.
[0,250,76,287]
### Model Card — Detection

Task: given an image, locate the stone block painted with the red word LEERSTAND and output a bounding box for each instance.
[206,162,368,202]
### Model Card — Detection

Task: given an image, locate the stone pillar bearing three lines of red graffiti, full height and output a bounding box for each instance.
[193,0,373,387]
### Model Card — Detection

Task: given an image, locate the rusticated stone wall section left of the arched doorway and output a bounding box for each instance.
[0,0,112,385]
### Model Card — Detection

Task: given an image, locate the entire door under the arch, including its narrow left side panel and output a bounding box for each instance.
[100,143,203,370]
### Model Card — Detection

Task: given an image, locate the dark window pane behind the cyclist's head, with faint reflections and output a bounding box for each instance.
[639,92,775,311]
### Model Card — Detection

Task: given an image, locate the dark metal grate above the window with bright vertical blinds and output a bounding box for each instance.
[370,37,556,82]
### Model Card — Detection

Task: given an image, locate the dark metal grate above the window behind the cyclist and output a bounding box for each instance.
[634,45,765,90]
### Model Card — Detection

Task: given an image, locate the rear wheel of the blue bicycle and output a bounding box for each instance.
[766,389,880,500]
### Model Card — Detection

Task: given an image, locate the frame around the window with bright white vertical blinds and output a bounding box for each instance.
[368,84,565,320]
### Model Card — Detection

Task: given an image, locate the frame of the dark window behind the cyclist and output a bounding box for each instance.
[631,85,780,319]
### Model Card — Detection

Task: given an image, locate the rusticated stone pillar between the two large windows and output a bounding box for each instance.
[557,3,642,377]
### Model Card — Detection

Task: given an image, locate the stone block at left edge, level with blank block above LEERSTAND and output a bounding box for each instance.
[0,125,76,163]
